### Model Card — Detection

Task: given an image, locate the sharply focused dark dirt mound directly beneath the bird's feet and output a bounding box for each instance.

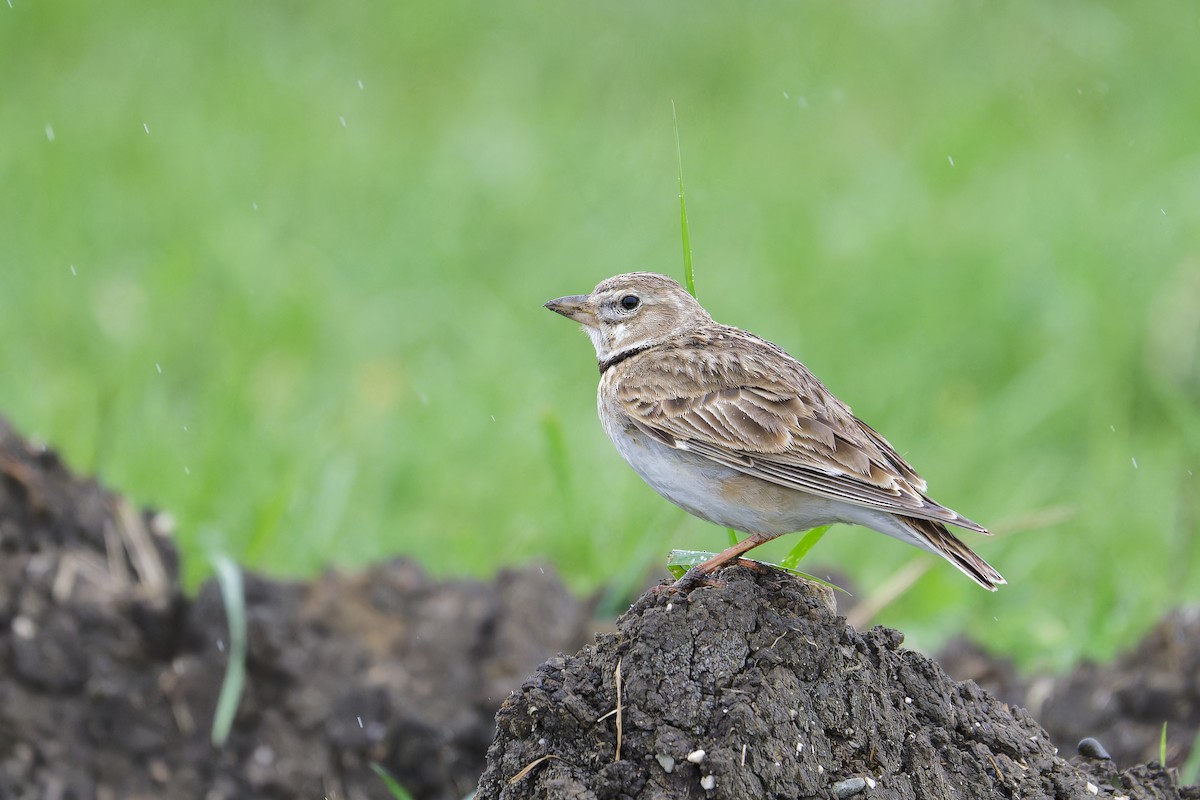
[476,566,1200,800]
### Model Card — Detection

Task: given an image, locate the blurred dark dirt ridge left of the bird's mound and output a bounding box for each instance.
[0,421,590,800]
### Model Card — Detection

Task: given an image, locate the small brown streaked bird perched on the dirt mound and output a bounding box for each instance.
[545,272,1007,591]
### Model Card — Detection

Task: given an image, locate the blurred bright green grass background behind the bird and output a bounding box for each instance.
[0,0,1200,664]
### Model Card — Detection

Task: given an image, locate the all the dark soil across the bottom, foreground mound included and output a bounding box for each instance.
[0,420,1200,800]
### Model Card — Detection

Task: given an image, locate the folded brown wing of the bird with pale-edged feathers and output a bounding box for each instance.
[614,329,988,533]
